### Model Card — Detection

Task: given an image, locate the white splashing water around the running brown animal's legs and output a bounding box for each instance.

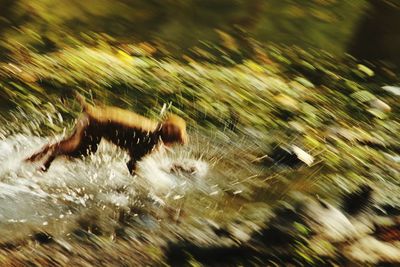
[0,134,208,241]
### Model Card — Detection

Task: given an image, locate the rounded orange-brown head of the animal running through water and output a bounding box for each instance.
[160,115,188,146]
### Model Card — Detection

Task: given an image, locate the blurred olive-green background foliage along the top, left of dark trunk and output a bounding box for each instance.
[0,0,368,57]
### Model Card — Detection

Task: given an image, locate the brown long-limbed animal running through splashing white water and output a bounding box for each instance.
[26,94,187,174]
